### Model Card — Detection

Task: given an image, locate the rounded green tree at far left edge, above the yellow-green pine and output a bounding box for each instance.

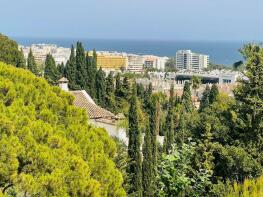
[0,33,26,68]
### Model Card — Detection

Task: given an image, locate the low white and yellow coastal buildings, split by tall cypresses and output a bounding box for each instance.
[20,44,169,73]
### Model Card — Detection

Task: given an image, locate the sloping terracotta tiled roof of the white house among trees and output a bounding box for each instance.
[70,90,116,119]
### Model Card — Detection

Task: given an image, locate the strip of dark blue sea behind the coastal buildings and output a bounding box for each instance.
[14,38,248,66]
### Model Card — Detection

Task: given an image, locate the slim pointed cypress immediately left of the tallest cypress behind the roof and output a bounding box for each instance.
[65,45,79,90]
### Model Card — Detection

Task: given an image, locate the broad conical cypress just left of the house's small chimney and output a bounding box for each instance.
[44,54,60,85]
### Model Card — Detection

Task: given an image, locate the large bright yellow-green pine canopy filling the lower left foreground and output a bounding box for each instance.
[0,62,126,196]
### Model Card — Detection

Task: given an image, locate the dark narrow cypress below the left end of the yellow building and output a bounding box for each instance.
[95,68,106,107]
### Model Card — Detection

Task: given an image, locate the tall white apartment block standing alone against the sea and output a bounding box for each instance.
[176,50,209,70]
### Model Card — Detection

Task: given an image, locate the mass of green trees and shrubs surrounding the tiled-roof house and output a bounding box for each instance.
[0,33,263,197]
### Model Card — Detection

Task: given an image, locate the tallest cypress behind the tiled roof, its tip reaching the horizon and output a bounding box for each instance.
[76,42,87,89]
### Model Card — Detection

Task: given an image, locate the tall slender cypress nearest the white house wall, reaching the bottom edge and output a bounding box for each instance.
[128,84,142,197]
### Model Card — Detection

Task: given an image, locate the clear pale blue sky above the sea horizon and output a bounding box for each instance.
[0,0,263,41]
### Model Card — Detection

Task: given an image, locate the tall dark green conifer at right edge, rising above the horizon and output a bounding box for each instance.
[235,44,263,147]
